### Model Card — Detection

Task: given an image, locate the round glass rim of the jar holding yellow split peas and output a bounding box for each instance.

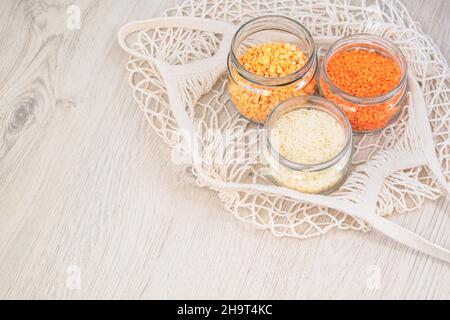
[228,15,317,87]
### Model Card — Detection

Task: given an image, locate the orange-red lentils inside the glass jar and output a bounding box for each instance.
[321,49,404,132]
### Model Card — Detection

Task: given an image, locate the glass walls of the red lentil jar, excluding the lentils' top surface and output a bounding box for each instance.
[319,34,407,133]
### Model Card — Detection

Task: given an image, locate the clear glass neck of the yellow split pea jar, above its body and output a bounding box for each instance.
[228,15,317,86]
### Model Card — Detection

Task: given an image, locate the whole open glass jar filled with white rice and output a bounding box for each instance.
[262,96,352,194]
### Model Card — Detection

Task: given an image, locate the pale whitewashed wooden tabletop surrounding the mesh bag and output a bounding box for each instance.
[0,0,450,299]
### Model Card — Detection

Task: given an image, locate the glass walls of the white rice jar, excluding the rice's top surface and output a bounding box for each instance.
[261,96,353,194]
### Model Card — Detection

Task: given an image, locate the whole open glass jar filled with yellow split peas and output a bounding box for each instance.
[228,15,318,123]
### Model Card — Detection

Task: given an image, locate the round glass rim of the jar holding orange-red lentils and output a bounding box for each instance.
[321,33,408,105]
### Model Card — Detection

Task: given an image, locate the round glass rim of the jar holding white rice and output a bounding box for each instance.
[263,95,353,171]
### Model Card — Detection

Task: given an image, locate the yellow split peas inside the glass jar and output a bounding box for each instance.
[229,42,315,123]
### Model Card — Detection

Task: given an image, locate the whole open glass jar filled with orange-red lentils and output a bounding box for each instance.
[319,34,407,133]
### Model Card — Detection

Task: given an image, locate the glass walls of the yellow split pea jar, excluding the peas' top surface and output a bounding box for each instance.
[228,15,318,123]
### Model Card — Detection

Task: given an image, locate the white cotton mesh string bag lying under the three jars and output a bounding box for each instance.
[118,0,450,262]
